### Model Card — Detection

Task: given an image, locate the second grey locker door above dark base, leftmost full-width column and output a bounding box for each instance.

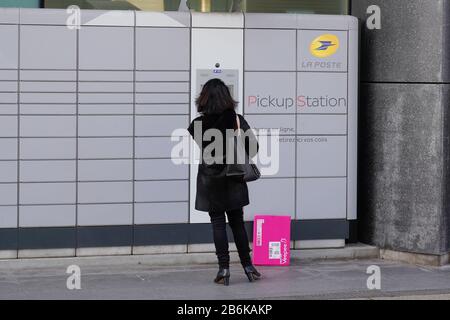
[19,183,75,204]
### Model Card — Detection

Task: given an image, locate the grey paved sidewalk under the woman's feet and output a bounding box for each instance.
[0,257,450,299]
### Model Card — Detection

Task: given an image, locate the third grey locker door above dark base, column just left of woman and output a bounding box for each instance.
[135,159,189,180]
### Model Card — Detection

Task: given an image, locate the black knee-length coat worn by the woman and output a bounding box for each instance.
[188,109,258,212]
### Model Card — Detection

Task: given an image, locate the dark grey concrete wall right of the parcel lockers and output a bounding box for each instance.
[352,0,450,254]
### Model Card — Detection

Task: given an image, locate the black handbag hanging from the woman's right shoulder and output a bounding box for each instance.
[226,116,261,182]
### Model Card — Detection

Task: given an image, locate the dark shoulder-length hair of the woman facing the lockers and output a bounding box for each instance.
[195,78,237,114]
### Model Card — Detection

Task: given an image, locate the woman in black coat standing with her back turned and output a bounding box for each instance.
[188,79,261,285]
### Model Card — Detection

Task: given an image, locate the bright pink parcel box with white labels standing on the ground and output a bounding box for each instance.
[253,215,291,266]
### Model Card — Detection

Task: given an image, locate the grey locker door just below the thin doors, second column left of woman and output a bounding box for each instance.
[78,116,133,137]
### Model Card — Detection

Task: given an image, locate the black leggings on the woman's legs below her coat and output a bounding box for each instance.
[209,208,252,268]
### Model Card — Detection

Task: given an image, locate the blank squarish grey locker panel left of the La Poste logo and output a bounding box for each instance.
[244,29,296,71]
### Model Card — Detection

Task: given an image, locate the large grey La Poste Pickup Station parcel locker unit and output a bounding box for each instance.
[0,9,358,257]
